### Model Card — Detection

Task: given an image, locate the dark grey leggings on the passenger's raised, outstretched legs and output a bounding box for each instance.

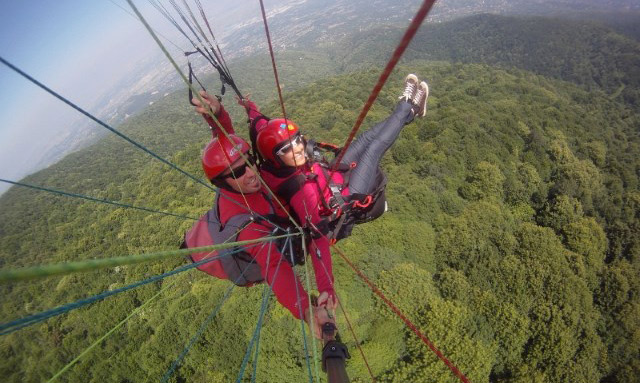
[341,101,413,194]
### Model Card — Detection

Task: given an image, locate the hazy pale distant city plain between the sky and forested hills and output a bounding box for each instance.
[8,0,640,193]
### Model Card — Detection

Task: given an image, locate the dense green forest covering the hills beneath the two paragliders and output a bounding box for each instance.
[0,12,640,382]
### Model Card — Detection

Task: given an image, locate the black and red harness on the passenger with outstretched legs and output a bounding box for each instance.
[277,140,387,243]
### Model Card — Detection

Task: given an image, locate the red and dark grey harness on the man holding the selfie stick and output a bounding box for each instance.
[180,193,304,286]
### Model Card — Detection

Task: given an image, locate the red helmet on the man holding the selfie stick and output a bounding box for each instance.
[202,134,249,179]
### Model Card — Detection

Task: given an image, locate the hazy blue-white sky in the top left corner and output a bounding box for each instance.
[0,0,165,186]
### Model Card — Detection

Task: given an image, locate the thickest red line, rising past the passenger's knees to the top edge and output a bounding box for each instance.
[330,0,436,172]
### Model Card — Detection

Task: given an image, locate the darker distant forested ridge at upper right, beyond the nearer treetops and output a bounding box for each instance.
[336,15,640,107]
